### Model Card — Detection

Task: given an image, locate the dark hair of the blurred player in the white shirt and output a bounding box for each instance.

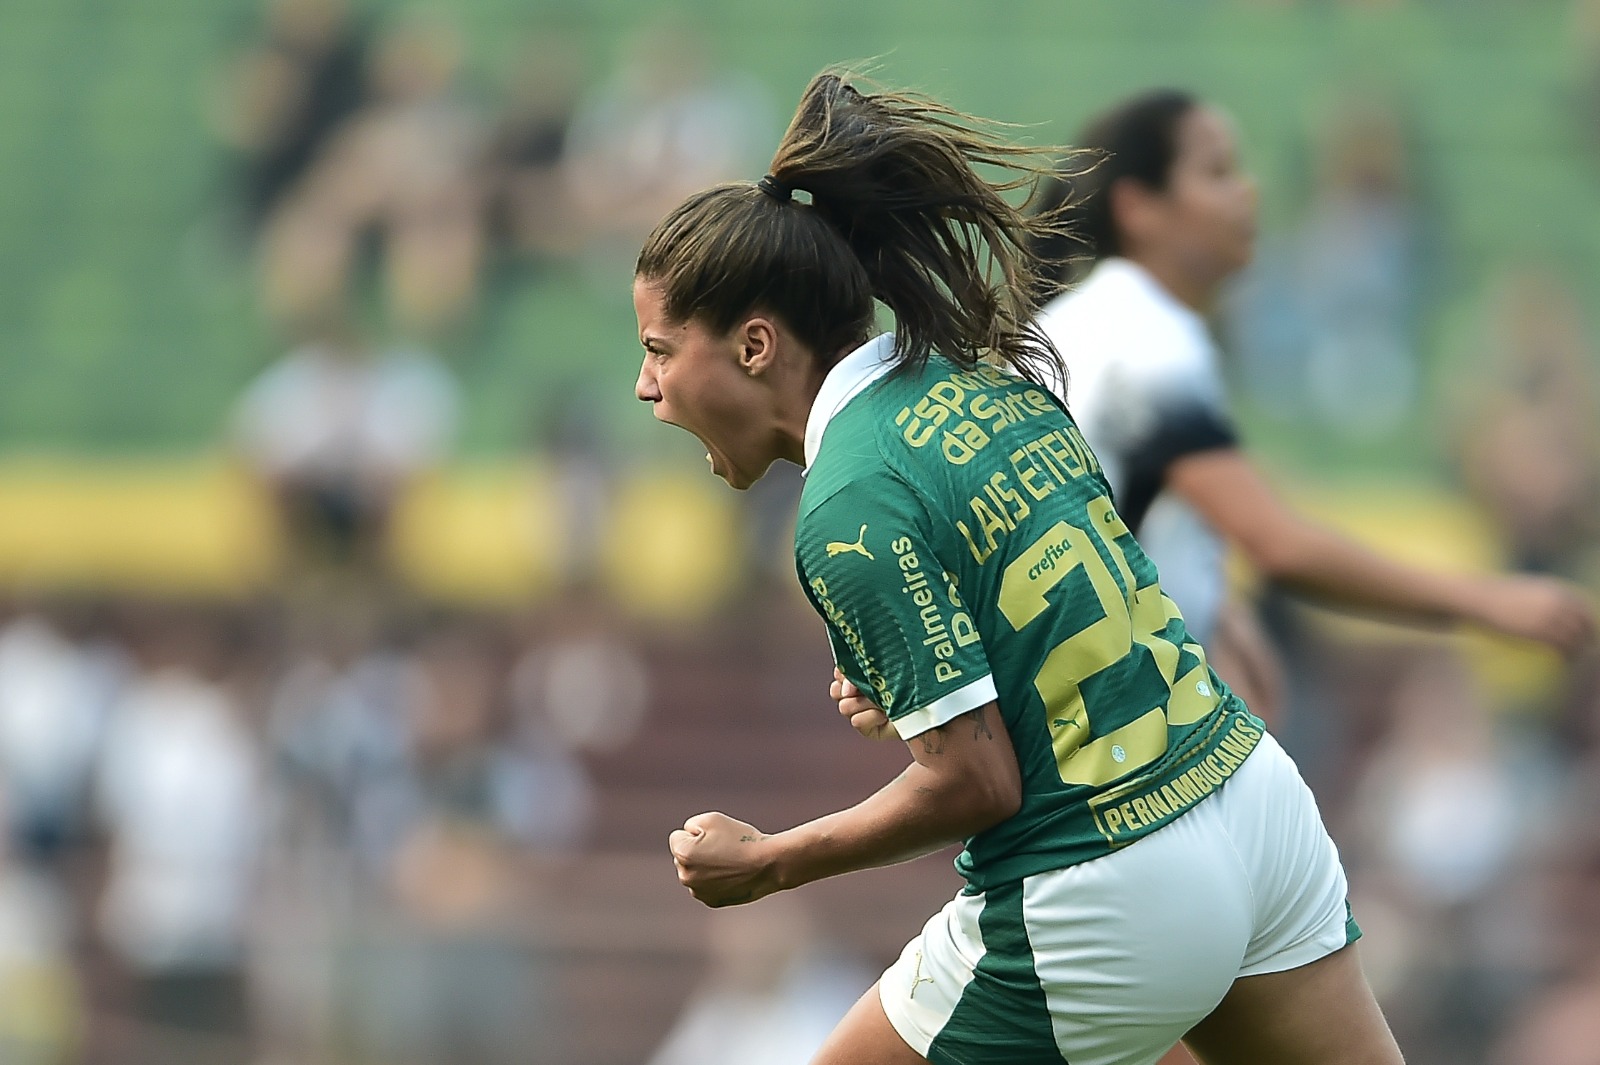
[1034,90,1200,304]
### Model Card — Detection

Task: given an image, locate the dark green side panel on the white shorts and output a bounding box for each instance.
[928,881,1064,1065]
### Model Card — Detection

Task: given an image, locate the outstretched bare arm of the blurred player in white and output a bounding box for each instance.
[1166,448,1595,654]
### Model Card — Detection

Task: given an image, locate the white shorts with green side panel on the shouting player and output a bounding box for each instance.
[878,736,1360,1065]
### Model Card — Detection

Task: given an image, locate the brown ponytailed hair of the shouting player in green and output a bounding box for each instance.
[635,72,1061,381]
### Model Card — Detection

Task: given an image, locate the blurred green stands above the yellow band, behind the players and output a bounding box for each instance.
[0,0,1600,470]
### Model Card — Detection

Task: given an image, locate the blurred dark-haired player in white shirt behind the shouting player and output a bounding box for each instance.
[1037,90,1592,705]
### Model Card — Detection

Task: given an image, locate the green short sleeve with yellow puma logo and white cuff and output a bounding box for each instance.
[795,473,995,739]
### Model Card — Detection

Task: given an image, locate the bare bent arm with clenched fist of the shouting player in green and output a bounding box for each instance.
[669,702,1022,907]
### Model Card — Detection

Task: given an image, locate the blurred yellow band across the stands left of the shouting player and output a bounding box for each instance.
[0,459,741,619]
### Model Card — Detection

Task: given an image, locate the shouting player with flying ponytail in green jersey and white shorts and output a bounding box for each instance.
[634,74,1400,1065]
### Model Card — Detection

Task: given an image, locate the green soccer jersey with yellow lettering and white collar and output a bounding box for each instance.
[795,336,1264,891]
